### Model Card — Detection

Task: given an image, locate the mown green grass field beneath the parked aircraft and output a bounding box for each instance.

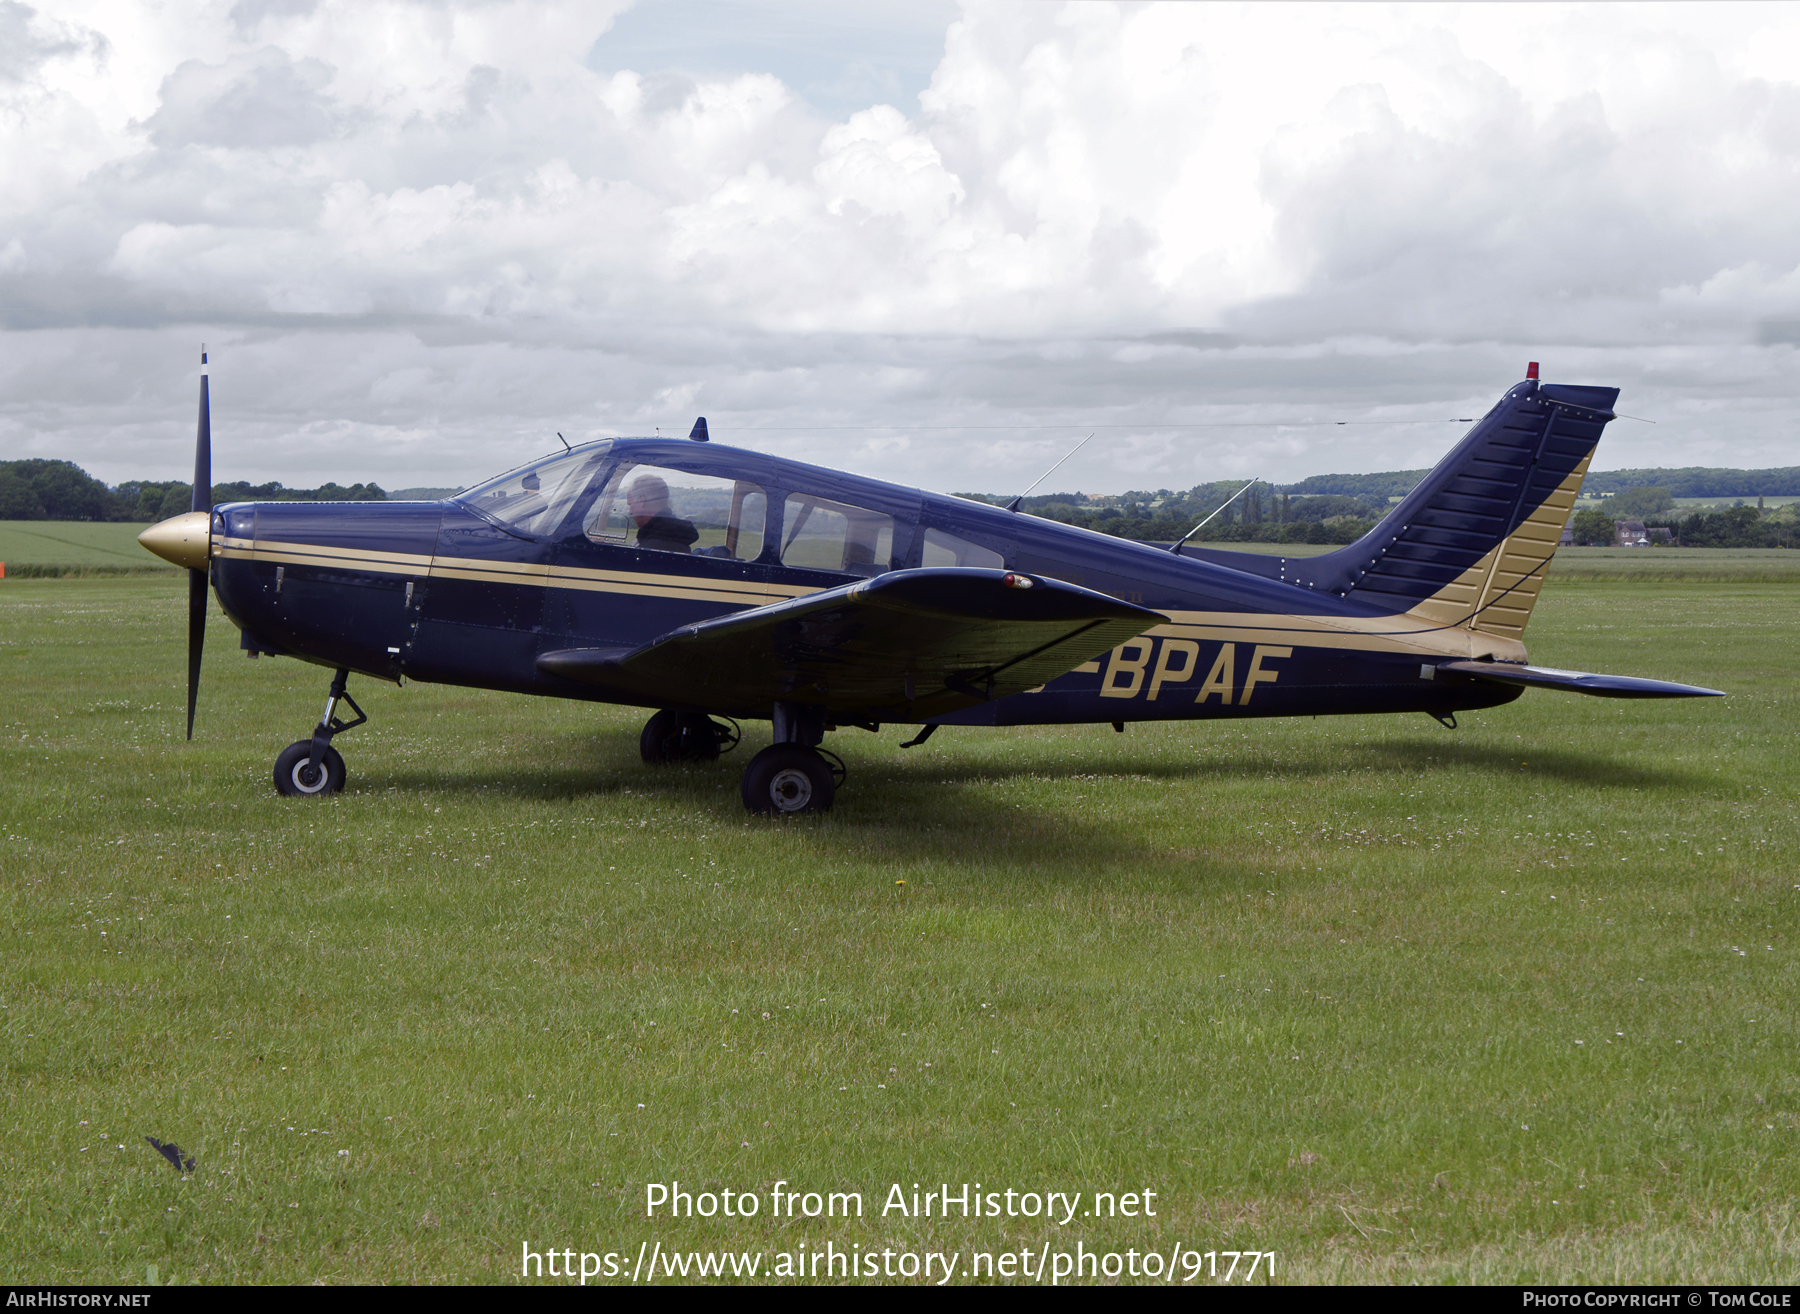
[0,580,1800,1283]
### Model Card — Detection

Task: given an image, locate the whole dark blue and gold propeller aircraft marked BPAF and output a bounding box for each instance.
[140,353,1717,814]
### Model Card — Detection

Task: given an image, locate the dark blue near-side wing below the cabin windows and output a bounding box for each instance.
[538,569,1168,720]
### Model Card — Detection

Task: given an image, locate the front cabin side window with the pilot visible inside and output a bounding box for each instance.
[581,461,769,562]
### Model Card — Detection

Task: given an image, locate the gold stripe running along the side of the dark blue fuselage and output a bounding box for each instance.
[214,536,1526,659]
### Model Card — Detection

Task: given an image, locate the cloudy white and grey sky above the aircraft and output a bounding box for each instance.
[0,0,1800,491]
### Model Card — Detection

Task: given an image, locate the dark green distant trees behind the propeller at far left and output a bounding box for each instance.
[0,461,387,524]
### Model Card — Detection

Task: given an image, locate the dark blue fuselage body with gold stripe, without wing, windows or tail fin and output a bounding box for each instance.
[212,439,1523,725]
